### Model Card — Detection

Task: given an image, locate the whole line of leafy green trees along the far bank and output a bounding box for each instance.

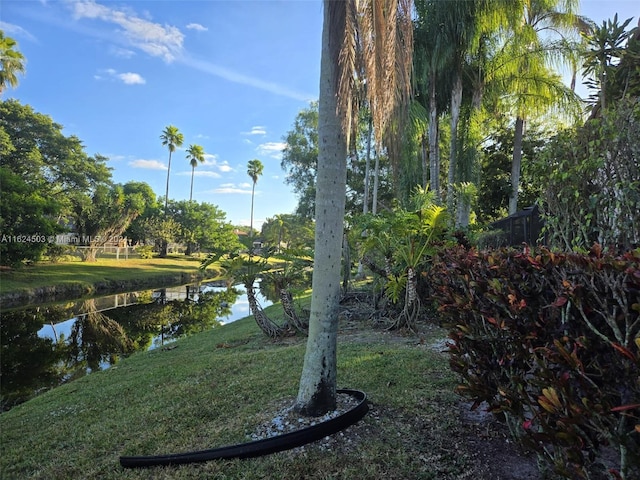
[0,100,242,266]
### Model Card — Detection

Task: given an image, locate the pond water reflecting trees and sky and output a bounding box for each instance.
[0,282,272,411]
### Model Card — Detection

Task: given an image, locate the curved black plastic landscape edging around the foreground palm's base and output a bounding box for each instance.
[120,389,369,468]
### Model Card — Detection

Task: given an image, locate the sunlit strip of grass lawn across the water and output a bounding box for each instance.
[0,255,205,294]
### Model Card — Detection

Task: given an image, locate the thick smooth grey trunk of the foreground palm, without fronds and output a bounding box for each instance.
[296,0,347,416]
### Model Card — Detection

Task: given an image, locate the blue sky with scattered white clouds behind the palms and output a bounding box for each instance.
[0,0,640,228]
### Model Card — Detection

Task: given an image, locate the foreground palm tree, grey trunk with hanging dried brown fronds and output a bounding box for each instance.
[296,0,413,416]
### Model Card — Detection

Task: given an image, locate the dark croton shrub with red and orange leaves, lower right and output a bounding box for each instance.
[430,245,640,479]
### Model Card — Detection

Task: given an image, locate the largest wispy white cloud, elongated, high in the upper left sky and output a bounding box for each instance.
[71,0,184,62]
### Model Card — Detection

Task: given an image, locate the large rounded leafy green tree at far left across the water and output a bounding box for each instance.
[0,100,111,265]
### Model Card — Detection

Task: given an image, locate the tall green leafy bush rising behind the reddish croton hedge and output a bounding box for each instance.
[536,99,640,251]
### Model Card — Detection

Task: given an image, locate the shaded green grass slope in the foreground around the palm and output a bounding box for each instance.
[0,302,479,480]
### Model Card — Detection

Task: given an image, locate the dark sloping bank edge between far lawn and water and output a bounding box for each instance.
[0,272,209,311]
